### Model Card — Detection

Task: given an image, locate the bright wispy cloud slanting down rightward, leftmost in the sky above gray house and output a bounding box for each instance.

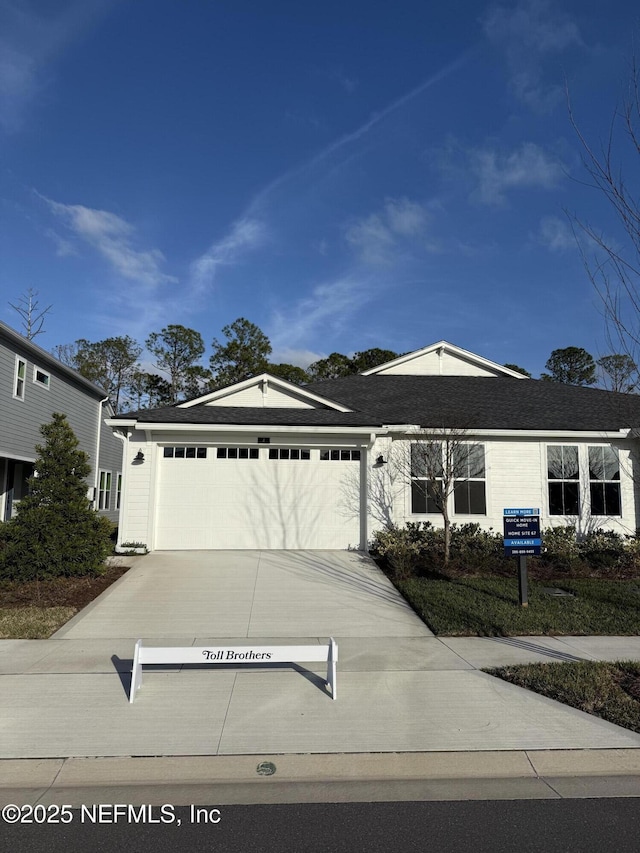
[40,196,177,286]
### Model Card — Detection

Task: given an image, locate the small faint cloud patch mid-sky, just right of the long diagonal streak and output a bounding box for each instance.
[345,198,431,266]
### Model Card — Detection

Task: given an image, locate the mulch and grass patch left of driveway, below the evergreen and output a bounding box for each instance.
[0,565,129,640]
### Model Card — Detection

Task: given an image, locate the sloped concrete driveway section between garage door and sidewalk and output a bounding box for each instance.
[54,551,433,640]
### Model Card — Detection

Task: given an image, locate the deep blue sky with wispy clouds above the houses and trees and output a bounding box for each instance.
[0,0,638,376]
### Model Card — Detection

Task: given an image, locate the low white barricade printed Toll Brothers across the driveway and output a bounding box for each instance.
[129,637,338,702]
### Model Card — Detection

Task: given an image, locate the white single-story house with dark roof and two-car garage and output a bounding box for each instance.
[108,341,640,550]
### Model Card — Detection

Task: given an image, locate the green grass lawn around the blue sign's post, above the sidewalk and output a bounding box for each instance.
[395,572,640,637]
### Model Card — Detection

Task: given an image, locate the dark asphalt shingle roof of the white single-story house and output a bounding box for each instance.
[116,375,640,431]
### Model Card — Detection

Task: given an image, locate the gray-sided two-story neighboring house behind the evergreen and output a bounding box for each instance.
[0,322,122,523]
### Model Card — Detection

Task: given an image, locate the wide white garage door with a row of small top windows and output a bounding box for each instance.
[155,446,361,550]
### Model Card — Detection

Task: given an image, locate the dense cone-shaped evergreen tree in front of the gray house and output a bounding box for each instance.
[0,413,111,580]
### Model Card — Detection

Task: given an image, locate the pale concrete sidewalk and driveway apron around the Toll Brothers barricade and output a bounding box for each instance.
[0,637,640,758]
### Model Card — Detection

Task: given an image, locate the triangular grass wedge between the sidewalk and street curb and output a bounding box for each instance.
[485,661,640,732]
